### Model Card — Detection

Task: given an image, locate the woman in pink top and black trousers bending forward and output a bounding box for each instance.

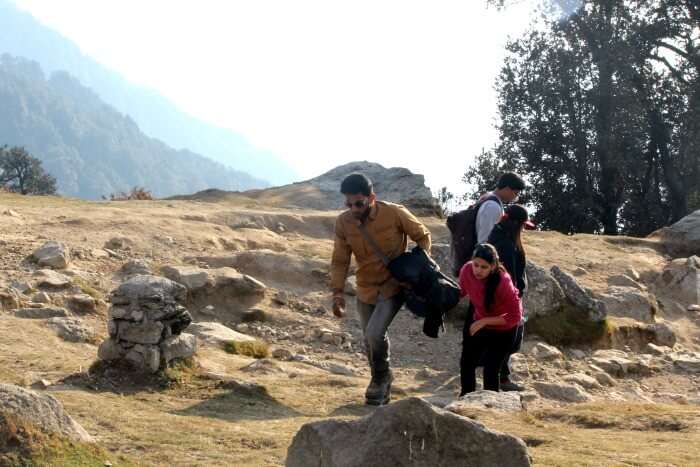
[459,243,523,396]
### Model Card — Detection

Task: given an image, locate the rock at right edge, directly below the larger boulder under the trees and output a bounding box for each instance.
[654,256,700,305]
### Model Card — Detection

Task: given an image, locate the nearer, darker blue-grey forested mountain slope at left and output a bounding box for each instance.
[0,54,264,199]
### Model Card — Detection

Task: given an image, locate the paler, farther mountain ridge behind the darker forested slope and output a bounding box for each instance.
[0,0,297,185]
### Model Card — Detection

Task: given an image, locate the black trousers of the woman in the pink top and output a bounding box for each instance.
[460,320,520,395]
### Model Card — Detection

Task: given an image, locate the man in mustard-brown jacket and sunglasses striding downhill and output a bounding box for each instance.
[331,174,431,405]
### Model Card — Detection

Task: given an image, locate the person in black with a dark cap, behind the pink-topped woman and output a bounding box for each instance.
[488,204,535,391]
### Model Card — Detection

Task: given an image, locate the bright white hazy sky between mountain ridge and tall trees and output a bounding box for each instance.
[16,0,530,191]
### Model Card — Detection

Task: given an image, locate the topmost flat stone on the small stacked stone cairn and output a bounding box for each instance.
[112,275,187,305]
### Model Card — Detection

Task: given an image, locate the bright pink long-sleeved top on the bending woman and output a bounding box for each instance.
[459,261,523,331]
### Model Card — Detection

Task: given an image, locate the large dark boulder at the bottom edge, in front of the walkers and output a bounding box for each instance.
[285,398,530,467]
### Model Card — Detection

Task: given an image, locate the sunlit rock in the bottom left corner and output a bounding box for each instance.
[0,383,93,442]
